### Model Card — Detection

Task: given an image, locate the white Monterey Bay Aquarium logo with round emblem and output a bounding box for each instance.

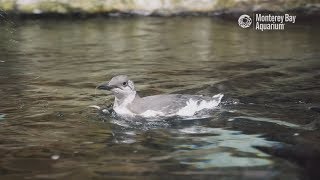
[238,14,297,31]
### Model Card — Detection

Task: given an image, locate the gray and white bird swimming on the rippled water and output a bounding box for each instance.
[98,75,223,117]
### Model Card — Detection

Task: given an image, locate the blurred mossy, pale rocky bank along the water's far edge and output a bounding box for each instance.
[0,0,320,16]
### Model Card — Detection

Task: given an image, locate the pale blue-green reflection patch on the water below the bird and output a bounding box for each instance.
[173,126,279,169]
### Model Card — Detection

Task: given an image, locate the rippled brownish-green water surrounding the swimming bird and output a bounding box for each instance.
[0,17,320,179]
